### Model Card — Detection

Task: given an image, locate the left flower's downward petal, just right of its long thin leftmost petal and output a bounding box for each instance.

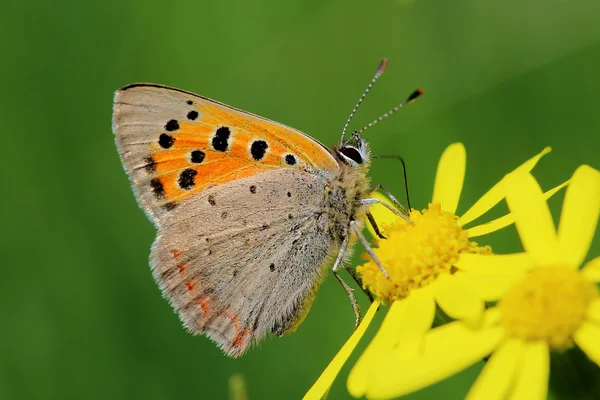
[347,296,410,397]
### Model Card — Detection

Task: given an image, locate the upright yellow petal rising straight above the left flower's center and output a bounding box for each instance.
[432,143,467,214]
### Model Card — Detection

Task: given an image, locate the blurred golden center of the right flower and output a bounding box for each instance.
[499,267,598,349]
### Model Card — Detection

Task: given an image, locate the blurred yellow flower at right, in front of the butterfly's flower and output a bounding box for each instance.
[366,166,600,400]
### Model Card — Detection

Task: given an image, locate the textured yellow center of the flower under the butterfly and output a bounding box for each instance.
[357,203,491,302]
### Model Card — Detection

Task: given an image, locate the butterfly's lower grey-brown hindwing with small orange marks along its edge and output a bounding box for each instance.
[151,169,338,356]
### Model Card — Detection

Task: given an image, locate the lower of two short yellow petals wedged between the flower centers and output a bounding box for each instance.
[452,271,523,301]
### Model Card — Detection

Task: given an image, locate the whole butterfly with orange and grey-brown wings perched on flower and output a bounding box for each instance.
[113,60,421,357]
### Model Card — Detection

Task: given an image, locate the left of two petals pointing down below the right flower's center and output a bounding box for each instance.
[466,339,524,400]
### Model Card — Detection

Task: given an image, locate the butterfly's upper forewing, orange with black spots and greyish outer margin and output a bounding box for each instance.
[113,84,338,225]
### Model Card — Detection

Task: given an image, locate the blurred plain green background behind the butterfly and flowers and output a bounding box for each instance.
[0,0,600,399]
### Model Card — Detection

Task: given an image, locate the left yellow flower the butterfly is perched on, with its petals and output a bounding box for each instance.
[305,143,566,399]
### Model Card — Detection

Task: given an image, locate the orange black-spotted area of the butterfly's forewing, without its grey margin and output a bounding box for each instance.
[139,98,338,209]
